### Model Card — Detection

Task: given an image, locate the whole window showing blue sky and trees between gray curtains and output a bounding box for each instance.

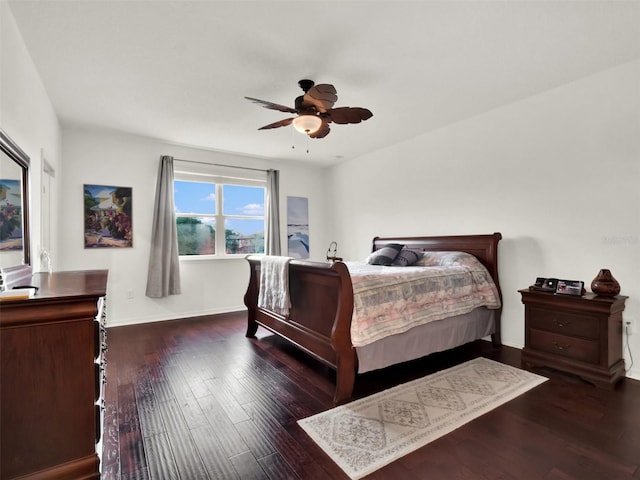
[173,171,266,257]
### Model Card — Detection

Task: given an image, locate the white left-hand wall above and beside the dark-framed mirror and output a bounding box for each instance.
[0,1,61,271]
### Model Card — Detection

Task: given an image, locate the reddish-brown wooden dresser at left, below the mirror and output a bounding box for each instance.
[0,270,108,480]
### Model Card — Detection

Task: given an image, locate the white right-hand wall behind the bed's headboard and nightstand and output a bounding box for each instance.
[327,61,640,377]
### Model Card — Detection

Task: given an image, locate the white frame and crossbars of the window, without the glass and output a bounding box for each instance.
[173,168,267,261]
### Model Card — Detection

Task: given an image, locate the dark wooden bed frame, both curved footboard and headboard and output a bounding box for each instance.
[244,233,502,403]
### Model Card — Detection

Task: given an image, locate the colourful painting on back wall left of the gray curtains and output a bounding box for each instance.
[84,185,133,248]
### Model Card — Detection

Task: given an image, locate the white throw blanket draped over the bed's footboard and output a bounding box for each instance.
[258,255,291,316]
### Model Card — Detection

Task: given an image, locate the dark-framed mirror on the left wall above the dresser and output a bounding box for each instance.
[0,129,31,269]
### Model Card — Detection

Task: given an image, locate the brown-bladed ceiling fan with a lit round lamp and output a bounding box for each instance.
[244,79,373,138]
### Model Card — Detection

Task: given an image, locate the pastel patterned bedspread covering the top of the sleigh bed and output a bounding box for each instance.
[345,262,500,347]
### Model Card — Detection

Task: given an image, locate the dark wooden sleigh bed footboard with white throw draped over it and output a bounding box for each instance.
[244,256,357,403]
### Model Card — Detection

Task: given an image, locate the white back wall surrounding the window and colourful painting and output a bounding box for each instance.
[58,129,328,326]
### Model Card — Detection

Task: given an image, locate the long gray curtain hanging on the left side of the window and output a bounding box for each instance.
[146,156,181,298]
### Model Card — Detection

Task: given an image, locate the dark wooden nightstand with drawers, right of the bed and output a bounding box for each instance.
[520,289,627,388]
